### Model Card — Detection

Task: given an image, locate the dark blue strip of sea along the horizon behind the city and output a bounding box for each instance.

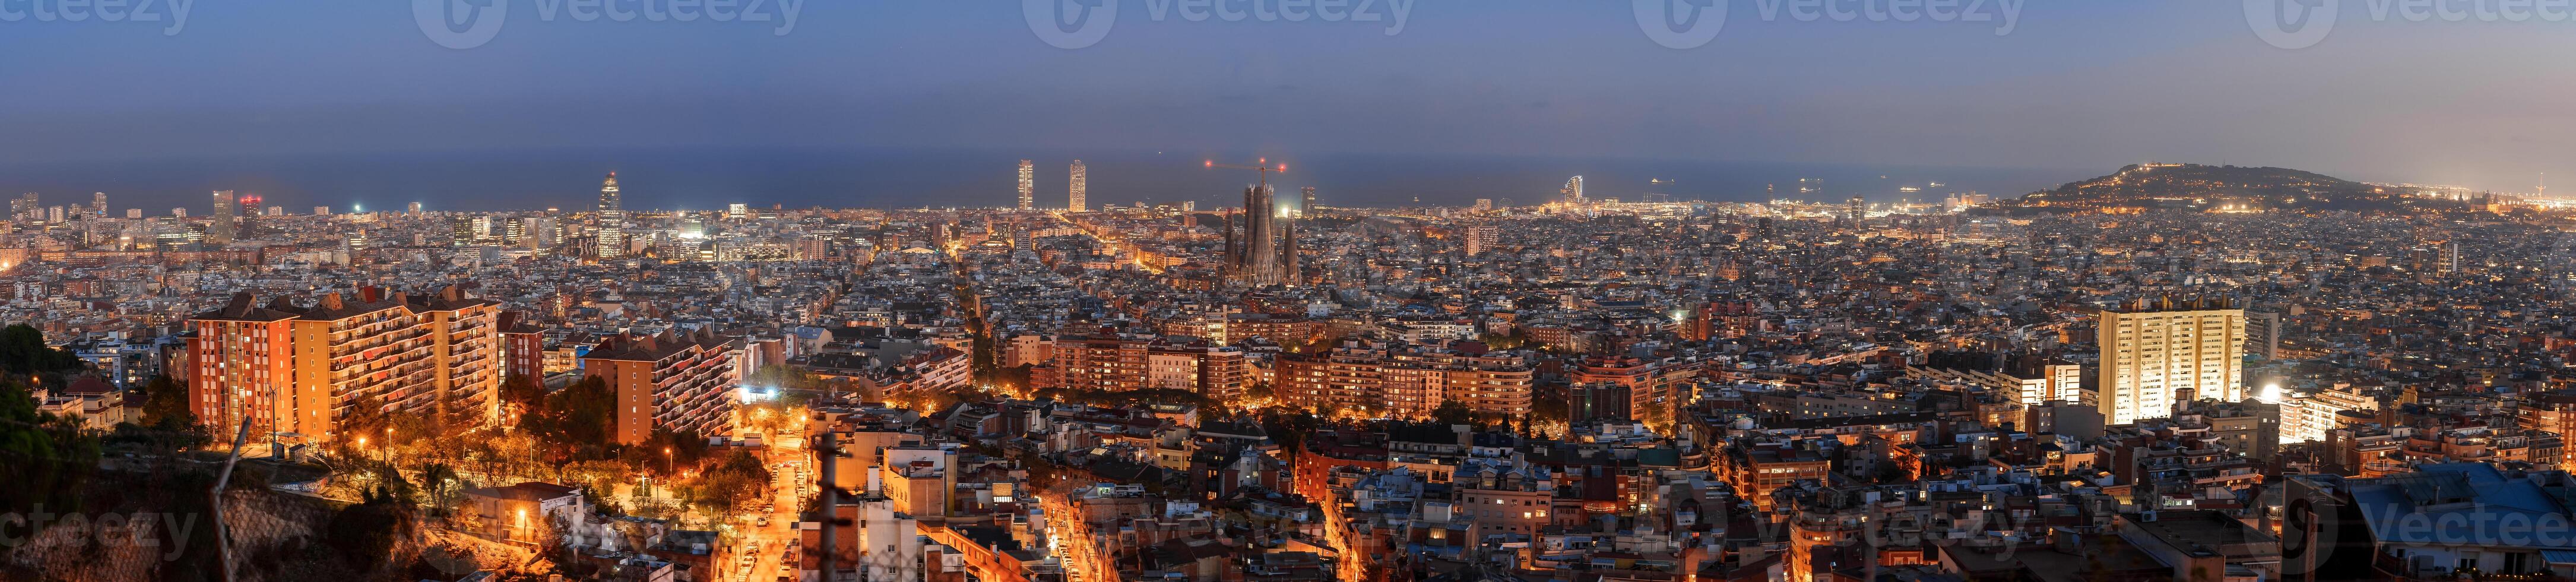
[0,150,2118,216]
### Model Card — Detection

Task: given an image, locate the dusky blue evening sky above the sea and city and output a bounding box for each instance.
[0,0,2576,204]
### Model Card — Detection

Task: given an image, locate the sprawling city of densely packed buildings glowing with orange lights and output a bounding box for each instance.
[5,162,2576,580]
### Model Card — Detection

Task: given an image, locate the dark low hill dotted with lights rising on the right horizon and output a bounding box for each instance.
[1999,165,2409,211]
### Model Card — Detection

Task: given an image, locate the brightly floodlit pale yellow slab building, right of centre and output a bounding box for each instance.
[2097,296,2247,425]
